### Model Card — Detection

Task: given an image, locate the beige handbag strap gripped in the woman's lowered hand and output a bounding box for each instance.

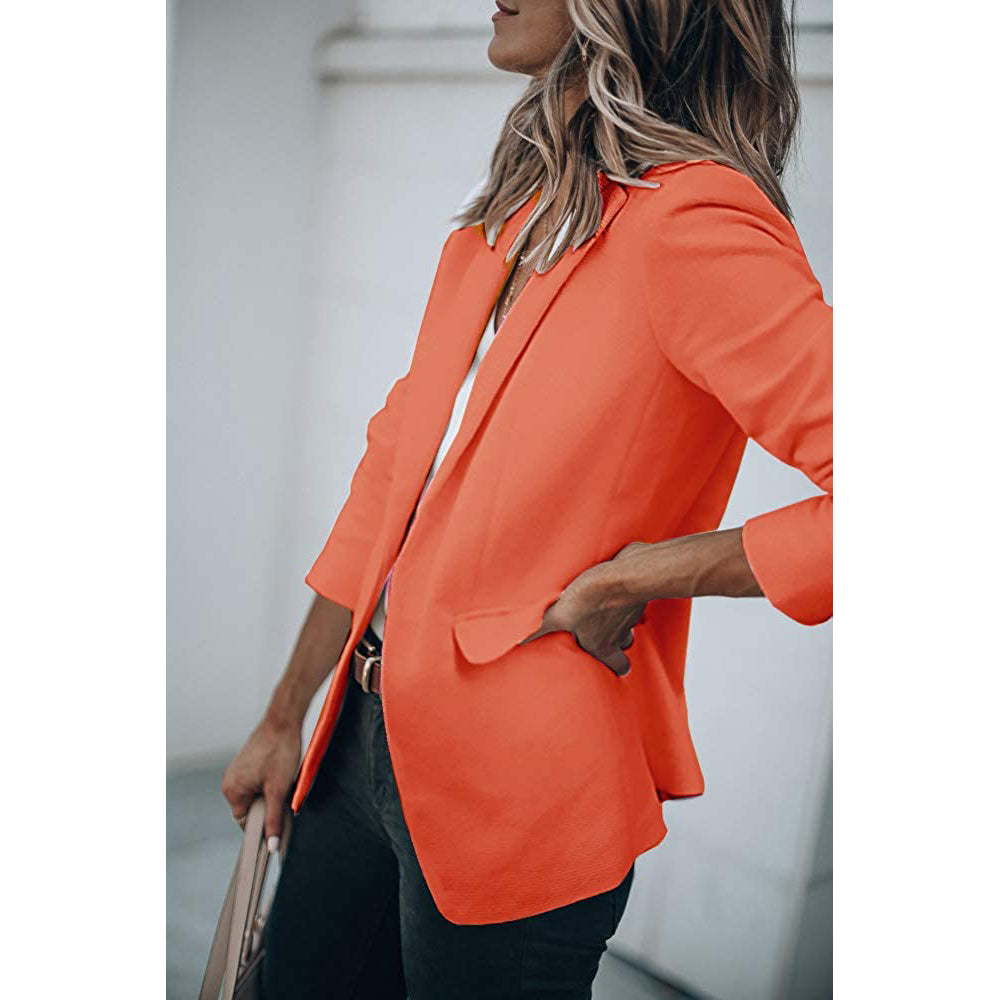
[198,798,291,1000]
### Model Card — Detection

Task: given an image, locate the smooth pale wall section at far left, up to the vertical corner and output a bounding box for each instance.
[167,0,350,764]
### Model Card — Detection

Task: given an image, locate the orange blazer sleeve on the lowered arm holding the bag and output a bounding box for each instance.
[306,373,410,611]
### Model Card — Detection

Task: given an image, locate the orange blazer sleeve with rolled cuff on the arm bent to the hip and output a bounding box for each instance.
[644,164,833,625]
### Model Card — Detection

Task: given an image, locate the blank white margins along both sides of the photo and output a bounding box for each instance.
[0,2,998,997]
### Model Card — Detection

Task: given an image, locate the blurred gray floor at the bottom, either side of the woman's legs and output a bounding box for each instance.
[167,769,685,1000]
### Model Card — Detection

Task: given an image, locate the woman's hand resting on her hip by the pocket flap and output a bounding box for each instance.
[519,542,647,677]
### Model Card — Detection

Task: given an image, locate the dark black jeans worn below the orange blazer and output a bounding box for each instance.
[263,656,634,1000]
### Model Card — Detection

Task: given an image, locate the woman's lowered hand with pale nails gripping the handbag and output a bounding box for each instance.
[222,719,302,840]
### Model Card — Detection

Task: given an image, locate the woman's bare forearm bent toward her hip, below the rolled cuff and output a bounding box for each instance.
[605,528,763,604]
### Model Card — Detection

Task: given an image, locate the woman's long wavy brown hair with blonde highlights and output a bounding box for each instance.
[455,0,799,272]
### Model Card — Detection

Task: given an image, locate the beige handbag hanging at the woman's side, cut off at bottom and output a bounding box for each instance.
[199,798,292,1000]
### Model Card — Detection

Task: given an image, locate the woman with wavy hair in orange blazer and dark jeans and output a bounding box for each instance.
[223,0,832,1000]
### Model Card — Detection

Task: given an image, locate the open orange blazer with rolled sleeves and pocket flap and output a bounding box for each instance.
[292,161,833,924]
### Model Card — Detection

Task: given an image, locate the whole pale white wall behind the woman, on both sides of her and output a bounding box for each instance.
[168,0,832,1000]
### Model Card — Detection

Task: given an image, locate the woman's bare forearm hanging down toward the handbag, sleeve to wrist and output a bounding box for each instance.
[265,595,351,728]
